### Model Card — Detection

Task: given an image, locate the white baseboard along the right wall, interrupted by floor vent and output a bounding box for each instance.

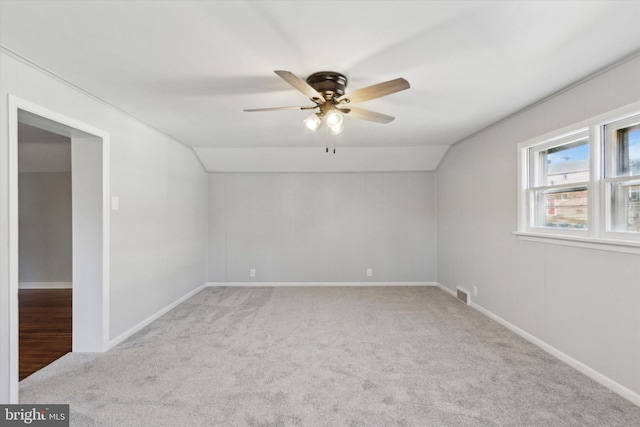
[437,283,640,406]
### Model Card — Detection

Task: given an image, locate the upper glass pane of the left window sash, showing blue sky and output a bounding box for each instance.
[538,139,589,186]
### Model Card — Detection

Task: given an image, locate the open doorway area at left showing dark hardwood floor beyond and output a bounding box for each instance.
[18,122,73,381]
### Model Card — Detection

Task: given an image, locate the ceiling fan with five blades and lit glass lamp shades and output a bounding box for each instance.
[244,70,410,135]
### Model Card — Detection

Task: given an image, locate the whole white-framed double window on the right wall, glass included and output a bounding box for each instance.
[516,103,640,248]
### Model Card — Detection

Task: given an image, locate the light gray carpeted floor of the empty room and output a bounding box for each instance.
[20,287,640,427]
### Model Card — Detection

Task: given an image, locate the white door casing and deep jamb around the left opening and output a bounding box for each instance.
[8,95,109,403]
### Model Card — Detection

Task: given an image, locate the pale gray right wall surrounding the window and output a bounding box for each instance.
[437,57,640,402]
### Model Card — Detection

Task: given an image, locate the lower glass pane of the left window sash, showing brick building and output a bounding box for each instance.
[536,188,587,230]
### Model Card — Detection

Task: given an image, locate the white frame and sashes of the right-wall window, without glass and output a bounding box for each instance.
[514,102,640,253]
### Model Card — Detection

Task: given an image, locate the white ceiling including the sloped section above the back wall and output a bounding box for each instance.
[0,0,640,171]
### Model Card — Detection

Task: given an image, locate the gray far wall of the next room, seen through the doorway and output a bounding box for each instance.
[18,172,72,283]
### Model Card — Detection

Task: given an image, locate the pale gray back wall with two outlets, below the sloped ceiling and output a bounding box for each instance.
[208,172,436,283]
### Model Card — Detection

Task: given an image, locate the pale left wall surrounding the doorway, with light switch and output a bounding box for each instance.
[0,52,207,402]
